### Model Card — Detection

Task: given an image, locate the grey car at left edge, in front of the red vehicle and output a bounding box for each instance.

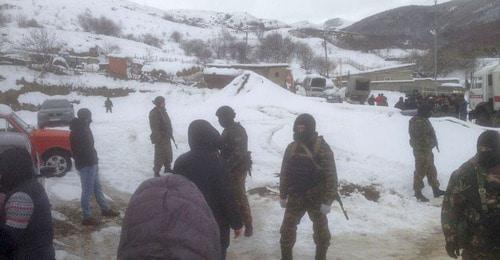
[0,132,57,178]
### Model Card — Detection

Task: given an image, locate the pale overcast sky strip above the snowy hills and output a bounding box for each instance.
[127,0,448,23]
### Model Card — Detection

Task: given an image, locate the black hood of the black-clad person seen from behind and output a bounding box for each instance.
[188,119,220,152]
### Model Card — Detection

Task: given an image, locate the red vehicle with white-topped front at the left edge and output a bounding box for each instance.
[0,104,72,176]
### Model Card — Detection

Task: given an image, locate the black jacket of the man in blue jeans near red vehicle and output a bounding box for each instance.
[69,118,98,170]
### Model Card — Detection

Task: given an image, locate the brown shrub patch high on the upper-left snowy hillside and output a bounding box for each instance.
[78,12,122,36]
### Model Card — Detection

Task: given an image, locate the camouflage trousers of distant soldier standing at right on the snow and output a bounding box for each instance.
[413,150,439,191]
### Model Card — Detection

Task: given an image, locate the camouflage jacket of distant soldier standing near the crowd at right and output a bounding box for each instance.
[408,116,437,150]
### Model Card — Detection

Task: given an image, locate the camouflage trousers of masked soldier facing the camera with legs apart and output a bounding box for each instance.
[280,194,331,259]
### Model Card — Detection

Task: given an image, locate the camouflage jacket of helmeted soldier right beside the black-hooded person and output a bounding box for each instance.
[219,123,251,172]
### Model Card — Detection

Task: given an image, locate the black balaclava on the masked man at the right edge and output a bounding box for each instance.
[477,130,500,169]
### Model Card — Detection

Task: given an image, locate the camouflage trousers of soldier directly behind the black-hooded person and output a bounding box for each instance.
[230,169,252,227]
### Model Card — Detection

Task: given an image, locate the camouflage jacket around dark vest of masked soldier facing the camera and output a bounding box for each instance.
[279,136,338,205]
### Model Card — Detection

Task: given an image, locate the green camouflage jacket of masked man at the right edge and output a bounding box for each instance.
[441,158,500,249]
